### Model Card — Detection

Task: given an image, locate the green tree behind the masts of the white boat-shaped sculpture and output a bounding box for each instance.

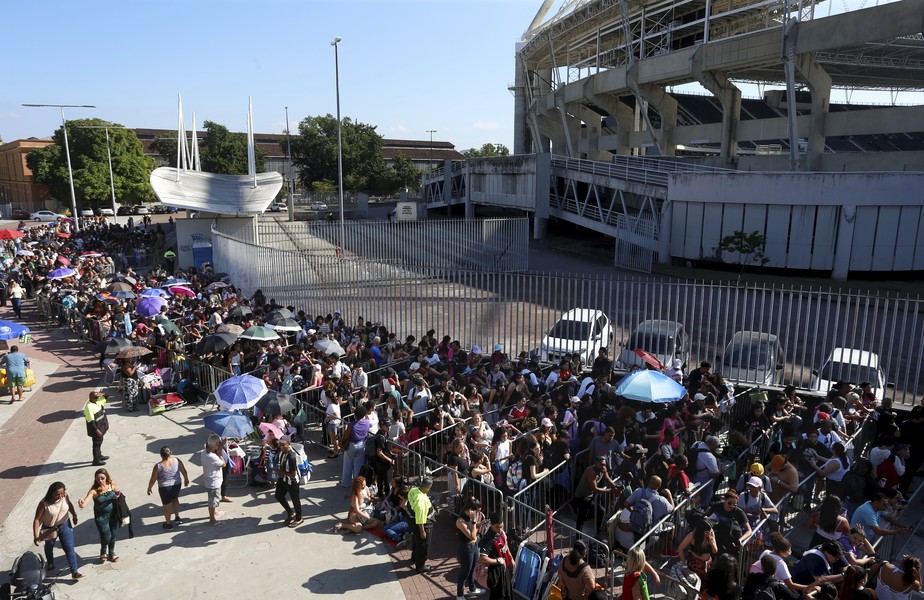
[151,121,266,175]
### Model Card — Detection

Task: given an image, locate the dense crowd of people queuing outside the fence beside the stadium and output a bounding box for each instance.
[14,216,924,600]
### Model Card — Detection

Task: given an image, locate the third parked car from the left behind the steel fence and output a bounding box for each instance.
[720,331,786,385]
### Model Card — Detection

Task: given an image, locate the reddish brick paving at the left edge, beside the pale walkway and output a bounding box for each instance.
[0,301,100,524]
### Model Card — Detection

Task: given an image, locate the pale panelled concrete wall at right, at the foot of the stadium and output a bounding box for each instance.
[662,173,924,279]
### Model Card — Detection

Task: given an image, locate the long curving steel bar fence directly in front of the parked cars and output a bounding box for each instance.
[213,224,924,405]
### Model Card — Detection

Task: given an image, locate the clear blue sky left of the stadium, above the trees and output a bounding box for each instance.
[0,0,540,150]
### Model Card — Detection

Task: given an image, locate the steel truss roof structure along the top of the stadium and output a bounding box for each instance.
[518,0,924,90]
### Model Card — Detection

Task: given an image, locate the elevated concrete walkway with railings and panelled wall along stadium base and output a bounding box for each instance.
[423,154,924,279]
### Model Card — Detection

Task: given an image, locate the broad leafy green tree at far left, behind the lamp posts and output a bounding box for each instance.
[26,119,156,206]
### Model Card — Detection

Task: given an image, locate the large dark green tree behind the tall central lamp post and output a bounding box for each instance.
[290,114,387,191]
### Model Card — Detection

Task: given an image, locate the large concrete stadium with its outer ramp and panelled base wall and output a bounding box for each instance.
[425,0,924,279]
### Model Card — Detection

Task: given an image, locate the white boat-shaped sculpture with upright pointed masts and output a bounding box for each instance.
[151,97,283,215]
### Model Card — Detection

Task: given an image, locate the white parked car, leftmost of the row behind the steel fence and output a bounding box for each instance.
[539,308,613,365]
